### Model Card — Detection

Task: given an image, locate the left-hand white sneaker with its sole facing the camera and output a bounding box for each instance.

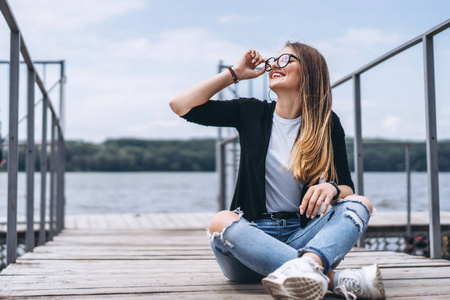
[262,257,329,300]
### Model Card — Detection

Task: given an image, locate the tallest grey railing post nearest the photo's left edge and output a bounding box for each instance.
[6,31,20,265]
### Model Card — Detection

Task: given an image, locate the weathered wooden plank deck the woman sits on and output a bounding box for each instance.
[0,213,450,299]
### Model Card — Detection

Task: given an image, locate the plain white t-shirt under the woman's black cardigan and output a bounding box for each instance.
[266,110,303,213]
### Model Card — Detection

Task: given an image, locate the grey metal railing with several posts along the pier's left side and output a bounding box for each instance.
[0,0,65,265]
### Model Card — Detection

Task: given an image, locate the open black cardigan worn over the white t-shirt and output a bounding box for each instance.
[182,98,354,227]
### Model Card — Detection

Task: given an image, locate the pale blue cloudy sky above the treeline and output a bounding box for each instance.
[0,0,450,142]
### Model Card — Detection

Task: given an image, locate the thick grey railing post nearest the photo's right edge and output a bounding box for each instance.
[423,35,441,258]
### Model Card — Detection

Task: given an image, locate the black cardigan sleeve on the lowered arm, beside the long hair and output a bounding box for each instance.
[331,112,355,192]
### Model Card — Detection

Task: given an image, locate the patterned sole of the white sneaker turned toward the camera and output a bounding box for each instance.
[262,277,324,300]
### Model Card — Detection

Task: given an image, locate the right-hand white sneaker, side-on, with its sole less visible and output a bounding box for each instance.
[333,264,385,300]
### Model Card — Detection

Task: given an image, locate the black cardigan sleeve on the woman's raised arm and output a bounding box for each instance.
[182,98,243,129]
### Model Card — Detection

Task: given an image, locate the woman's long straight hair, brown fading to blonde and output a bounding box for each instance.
[286,42,337,186]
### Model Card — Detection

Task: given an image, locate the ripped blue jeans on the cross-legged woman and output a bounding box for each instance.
[208,200,370,282]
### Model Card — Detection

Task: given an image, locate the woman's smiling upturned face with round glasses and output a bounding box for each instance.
[269,47,301,94]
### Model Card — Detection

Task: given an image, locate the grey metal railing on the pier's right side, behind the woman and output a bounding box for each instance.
[217,19,450,258]
